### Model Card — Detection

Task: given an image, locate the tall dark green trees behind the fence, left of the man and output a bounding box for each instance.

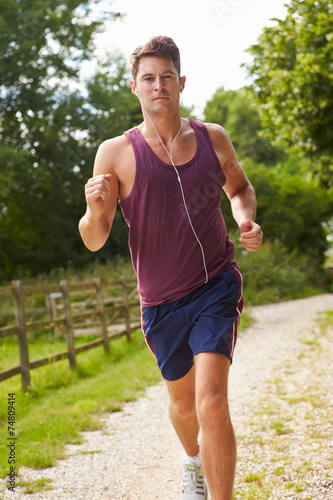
[0,0,140,279]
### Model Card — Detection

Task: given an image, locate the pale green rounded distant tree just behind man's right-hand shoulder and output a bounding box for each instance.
[204,87,286,165]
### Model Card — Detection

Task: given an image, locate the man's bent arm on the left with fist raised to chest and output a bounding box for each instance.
[79,141,119,252]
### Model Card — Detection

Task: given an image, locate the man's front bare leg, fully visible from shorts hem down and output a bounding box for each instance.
[195,352,236,500]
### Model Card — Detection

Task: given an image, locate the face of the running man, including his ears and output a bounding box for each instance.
[131,56,185,112]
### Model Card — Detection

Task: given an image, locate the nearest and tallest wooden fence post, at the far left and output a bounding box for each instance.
[12,281,30,390]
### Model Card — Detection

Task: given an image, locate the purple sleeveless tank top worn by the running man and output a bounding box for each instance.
[119,118,237,307]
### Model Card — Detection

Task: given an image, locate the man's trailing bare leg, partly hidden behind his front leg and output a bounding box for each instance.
[165,366,199,457]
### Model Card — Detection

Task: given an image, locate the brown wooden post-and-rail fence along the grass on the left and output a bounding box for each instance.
[0,278,141,389]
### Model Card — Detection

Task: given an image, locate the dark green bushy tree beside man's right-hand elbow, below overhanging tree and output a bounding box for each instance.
[243,158,333,268]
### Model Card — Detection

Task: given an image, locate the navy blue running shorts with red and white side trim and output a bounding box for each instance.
[142,268,243,381]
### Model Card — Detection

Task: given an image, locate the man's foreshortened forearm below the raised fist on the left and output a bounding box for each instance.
[79,211,110,252]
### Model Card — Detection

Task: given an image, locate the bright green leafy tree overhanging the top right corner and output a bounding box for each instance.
[246,0,333,186]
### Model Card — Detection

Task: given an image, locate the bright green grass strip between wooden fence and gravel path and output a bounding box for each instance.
[0,332,161,477]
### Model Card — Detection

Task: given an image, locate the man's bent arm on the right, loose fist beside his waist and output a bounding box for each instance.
[206,124,263,252]
